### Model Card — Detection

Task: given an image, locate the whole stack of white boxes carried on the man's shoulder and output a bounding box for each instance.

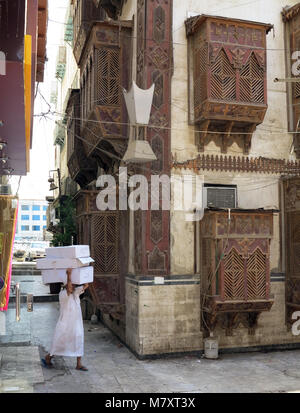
[37,245,94,284]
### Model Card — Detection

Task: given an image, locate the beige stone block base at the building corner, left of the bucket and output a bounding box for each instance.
[126,280,202,356]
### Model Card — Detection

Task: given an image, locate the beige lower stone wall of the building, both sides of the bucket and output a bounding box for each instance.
[126,280,300,356]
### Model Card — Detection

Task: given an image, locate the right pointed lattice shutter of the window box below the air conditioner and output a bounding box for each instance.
[247,249,267,299]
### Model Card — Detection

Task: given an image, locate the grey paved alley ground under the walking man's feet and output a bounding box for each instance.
[0,303,300,393]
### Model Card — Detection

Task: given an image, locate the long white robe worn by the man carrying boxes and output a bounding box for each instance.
[50,287,84,357]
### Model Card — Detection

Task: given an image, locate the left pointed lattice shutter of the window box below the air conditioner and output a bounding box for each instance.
[224,248,244,300]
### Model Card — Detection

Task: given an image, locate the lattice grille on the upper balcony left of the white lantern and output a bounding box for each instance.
[96,48,121,106]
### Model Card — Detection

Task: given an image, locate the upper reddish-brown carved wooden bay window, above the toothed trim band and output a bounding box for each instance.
[186,15,272,154]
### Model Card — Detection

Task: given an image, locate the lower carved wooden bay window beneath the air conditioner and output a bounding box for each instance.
[200,211,273,334]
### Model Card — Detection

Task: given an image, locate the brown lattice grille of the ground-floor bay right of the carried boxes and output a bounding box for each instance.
[92,212,120,274]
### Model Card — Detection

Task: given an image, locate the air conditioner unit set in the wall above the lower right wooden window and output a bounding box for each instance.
[203,186,237,209]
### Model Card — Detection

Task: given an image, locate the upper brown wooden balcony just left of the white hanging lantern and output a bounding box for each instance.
[80,22,132,169]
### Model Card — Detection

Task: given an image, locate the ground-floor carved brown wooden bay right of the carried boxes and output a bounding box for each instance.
[75,190,128,319]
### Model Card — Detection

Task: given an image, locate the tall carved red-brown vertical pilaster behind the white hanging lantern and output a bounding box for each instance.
[135,0,173,274]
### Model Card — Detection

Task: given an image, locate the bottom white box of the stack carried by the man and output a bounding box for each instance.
[42,266,94,285]
